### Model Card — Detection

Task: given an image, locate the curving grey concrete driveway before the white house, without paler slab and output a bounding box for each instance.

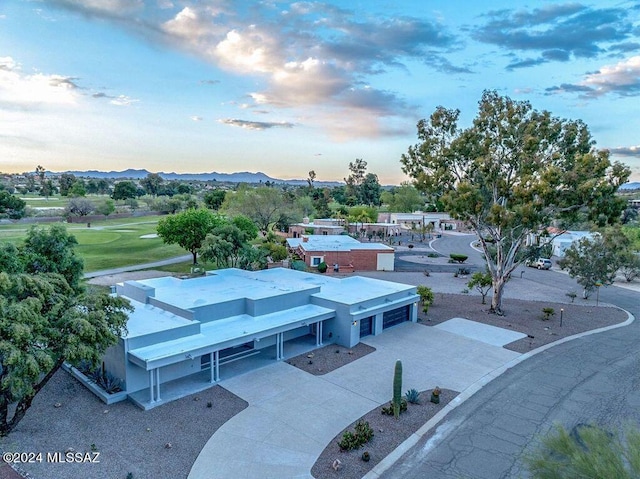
[189,323,519,479]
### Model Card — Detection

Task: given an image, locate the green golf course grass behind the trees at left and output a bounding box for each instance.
[0,216,188,272]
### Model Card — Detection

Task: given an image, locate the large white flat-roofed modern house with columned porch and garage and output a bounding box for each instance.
[77,268,419,409]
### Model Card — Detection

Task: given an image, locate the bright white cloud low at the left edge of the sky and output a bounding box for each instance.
[0,57,80,108]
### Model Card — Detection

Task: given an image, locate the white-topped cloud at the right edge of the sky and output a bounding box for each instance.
[546,56,640,98]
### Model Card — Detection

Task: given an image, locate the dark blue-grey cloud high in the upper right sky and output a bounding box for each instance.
[472,3,634,69]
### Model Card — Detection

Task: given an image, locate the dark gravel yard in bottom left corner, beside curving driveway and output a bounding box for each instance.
[0,370,248,479]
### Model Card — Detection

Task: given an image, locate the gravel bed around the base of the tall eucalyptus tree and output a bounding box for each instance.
[418,293,627,353]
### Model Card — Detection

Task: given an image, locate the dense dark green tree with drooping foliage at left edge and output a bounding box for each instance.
[0,226,130,435]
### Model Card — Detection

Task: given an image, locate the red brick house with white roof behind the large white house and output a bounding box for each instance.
[287,235,395,271]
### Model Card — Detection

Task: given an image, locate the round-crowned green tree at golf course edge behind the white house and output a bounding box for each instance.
[157,208,225,264]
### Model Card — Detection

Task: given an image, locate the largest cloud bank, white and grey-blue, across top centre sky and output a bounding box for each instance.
[41,0,460,139]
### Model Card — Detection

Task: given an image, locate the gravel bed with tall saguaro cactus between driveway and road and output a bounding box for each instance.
[311,389,458,479]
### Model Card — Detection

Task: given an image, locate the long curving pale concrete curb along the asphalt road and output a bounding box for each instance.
[362,306,635,479]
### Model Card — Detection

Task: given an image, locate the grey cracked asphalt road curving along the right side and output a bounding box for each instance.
[381,251,640,479]
